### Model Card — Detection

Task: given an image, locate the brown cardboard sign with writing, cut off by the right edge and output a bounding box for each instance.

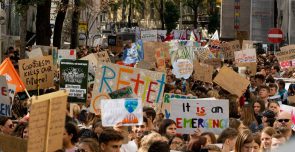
[275,45,295,69]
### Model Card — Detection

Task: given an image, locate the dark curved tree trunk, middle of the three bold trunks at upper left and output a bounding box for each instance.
[53,0,69,49]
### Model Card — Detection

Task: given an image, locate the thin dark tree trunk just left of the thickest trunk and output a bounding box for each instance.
[20,6,29,59]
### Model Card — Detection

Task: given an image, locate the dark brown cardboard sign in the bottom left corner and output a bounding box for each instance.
[0,133,28,152]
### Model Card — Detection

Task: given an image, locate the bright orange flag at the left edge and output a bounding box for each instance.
[0,58,26,92]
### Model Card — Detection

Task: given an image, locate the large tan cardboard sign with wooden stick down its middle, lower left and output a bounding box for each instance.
[28,91,68,152]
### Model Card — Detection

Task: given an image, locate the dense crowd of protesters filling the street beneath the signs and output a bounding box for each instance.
[0,43,295,152]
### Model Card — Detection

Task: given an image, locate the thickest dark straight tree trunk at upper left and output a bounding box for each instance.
[36,0,52,46]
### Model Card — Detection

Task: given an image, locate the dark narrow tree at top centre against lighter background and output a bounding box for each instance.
[164,1,179,33]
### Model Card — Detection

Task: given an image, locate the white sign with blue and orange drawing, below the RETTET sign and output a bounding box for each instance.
[101,99,143,126]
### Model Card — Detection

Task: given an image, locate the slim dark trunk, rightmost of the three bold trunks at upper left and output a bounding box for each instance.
[70,0,80,49]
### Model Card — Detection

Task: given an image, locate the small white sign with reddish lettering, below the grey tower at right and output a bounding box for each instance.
[235,49,256,63]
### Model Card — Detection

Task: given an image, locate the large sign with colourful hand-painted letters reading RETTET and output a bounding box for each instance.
[92,63,166,105]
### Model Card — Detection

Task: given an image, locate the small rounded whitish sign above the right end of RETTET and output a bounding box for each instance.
[172,59,194,79]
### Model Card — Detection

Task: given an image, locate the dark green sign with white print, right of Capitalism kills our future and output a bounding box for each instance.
[59,59,88,103]
